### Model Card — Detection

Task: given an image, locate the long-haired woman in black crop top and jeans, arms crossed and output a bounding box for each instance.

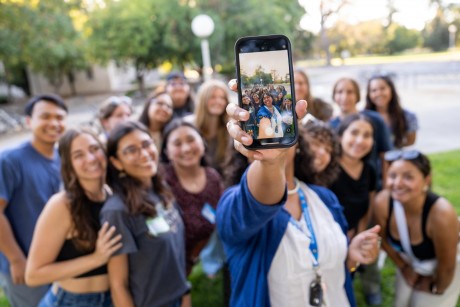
[26,129,121,306]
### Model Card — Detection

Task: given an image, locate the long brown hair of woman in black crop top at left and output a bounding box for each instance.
[59,129,104,251]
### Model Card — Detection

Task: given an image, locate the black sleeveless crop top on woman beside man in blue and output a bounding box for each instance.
[57,200,107,278]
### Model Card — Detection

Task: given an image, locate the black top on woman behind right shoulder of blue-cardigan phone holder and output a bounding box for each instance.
[330,161,376,230]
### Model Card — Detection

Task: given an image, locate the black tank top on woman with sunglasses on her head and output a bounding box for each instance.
[387,192,439,260]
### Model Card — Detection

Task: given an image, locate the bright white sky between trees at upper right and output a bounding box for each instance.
[298,0,460,34]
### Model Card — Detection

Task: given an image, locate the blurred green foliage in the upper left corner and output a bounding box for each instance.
[0,0,86,94]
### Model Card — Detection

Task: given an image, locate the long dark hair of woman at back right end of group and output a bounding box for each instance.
[366,76,407,147]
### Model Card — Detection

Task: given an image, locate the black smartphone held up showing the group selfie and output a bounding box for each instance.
[235,35,298,149]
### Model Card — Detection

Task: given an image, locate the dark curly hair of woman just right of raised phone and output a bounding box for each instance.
[294,121,340,187]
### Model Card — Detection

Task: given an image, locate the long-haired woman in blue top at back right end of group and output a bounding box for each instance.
[366,76,418,148]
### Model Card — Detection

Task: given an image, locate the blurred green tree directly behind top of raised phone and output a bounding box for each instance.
[194,0,306,75]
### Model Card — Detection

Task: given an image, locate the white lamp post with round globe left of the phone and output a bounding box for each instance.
[192,14,214,81]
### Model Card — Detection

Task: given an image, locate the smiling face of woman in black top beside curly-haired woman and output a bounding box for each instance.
[340,119,374,160]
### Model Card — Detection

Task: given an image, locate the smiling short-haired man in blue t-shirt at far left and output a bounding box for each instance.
[0,94,67,307]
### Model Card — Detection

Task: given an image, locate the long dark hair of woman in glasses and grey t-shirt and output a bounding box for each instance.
[107,121,173,216]
